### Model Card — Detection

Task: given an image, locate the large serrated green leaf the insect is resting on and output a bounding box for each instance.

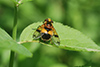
[20,22,100,52]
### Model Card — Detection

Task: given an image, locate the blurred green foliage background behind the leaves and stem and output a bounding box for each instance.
[0,0,100,67]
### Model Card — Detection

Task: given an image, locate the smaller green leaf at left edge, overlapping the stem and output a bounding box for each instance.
[0,28,32,57]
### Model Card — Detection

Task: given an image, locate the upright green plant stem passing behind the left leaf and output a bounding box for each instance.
[9,5,18,67]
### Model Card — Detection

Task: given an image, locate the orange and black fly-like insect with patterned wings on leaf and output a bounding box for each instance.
[33,18,60,46]
